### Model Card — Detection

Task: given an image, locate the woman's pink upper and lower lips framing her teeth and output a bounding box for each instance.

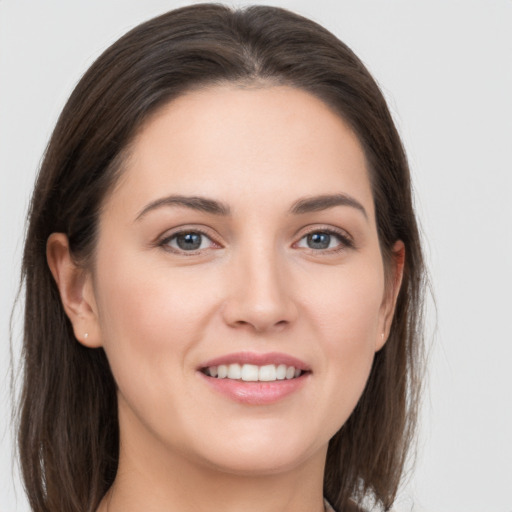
[197,352,311,405]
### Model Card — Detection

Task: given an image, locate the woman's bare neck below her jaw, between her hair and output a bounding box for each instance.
[98,412,327,512]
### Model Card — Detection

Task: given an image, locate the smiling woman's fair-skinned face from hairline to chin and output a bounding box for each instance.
[79,85,400,473]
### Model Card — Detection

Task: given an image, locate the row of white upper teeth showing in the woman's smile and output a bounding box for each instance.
[205,363,302,382]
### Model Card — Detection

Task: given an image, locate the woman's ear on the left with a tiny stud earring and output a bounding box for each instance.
[46,233,102,348]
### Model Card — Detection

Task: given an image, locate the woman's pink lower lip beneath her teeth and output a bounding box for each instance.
[198,372,310,405]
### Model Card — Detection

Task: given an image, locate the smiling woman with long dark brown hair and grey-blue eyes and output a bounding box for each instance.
[19,4,423,512]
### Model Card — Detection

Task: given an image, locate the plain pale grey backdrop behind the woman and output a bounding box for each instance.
[0,0,512,512]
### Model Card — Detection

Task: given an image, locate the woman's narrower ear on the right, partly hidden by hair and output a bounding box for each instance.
[375,240,405,352]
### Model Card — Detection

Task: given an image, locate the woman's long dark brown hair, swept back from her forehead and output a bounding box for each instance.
[18,4,424,512]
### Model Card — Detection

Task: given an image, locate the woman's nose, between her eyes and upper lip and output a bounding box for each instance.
[222,243,298,333]
